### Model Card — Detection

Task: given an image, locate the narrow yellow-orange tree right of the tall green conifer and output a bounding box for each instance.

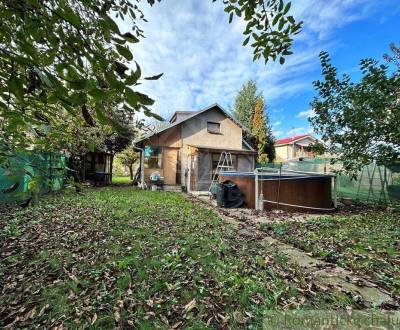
[251,97,275,163]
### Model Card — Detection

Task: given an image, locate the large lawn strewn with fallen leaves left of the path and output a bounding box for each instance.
[0,187,357,329]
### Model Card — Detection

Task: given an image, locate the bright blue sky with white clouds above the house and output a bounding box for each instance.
[121,0,400,138]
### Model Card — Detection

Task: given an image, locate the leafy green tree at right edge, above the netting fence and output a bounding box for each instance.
[310,52,400,177]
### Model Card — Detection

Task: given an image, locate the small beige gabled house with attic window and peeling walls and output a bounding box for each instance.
[135,104,256,191]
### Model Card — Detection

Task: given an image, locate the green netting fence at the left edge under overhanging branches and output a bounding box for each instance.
[0,151,67,204]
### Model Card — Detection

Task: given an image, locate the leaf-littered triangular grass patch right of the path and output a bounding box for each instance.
[263,211,400,296]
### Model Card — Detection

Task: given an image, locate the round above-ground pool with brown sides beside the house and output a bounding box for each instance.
[219,172,334,212]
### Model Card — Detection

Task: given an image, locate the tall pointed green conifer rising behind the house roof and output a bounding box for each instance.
[232,80,262,132]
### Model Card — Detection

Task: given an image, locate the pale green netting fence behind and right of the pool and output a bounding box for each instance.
[259,159,400,203]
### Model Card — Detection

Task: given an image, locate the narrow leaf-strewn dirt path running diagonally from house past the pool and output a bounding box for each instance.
[189,196,394,308]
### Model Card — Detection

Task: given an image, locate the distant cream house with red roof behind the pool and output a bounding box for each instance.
[275,134,317,162]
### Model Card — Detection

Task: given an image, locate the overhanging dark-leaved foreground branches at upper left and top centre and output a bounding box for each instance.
[0,0,302,160]
